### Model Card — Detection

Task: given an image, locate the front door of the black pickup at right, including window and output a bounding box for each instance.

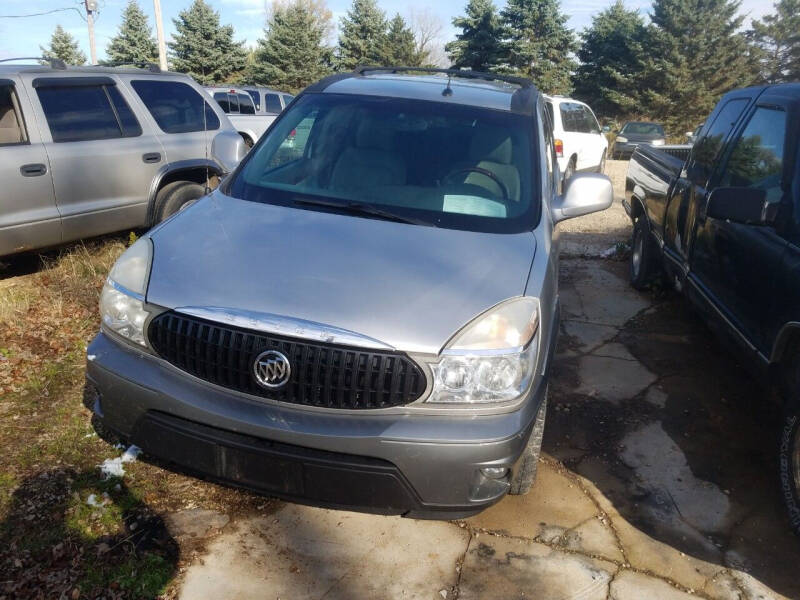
[692,95,789,354]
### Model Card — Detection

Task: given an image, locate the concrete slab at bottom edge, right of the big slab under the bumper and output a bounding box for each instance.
[458,535,617,600]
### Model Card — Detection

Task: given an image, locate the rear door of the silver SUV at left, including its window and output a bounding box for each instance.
[25,75,164,241]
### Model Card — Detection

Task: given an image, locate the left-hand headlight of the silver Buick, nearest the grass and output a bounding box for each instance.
[100,238,153,346]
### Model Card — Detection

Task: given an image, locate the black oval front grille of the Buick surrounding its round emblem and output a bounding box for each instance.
[148,311,426,409]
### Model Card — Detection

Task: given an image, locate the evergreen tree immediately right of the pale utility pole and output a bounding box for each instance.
[169,0,247,85]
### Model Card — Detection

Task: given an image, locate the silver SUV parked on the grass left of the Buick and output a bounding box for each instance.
[0,61,245,256]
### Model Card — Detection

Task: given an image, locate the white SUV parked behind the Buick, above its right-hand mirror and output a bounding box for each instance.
[545,96,608,182]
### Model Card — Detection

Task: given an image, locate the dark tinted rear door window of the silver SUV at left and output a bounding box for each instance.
[36,84,142,142]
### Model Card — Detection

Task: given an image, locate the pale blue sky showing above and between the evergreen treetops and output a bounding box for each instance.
[0,0,772,59]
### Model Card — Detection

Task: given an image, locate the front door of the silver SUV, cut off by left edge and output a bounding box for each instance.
[0,76,61,256]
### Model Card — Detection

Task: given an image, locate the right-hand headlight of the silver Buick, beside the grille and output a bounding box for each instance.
[426,298,539,404]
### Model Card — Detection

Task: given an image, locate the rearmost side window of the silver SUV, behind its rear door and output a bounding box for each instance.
[131,79,219,133]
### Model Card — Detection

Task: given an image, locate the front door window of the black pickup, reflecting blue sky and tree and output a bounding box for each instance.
[719,107,786,202]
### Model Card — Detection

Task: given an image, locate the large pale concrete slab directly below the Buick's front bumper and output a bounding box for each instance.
[180,504,469,600]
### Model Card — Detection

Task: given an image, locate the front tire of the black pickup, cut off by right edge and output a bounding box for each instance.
[778,344,800,535]
